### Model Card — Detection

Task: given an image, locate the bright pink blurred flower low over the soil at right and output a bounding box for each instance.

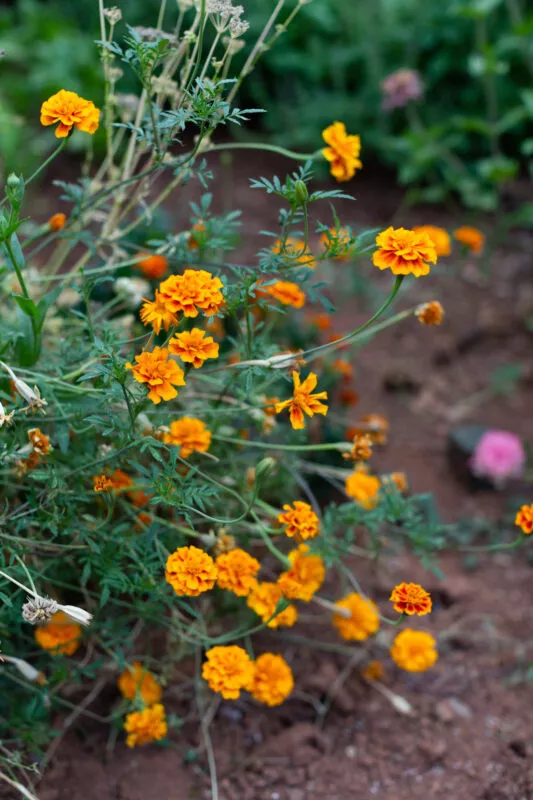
[469,430,526,486]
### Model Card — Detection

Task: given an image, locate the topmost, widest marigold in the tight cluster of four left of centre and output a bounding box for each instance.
[159,269,224,317]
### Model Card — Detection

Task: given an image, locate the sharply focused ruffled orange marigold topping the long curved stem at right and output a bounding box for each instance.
[372,226,437,278]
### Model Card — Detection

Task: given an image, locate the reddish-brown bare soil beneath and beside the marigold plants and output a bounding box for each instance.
[23,158,533,800]
